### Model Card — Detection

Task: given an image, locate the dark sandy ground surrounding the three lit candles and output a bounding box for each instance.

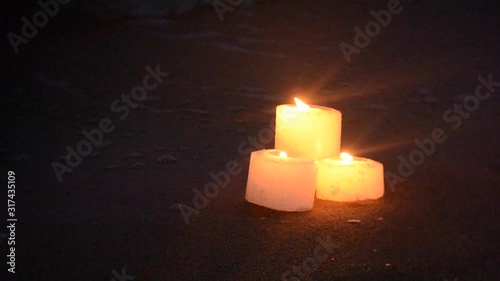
[0,0,500,281]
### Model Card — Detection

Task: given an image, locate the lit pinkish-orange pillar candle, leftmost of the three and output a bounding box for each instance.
[245,149,316,212]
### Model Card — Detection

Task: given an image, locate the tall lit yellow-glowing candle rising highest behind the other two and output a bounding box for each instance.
[275,99,342,160]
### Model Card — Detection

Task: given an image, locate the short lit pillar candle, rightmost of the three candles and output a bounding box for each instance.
[316,153,384,202]
